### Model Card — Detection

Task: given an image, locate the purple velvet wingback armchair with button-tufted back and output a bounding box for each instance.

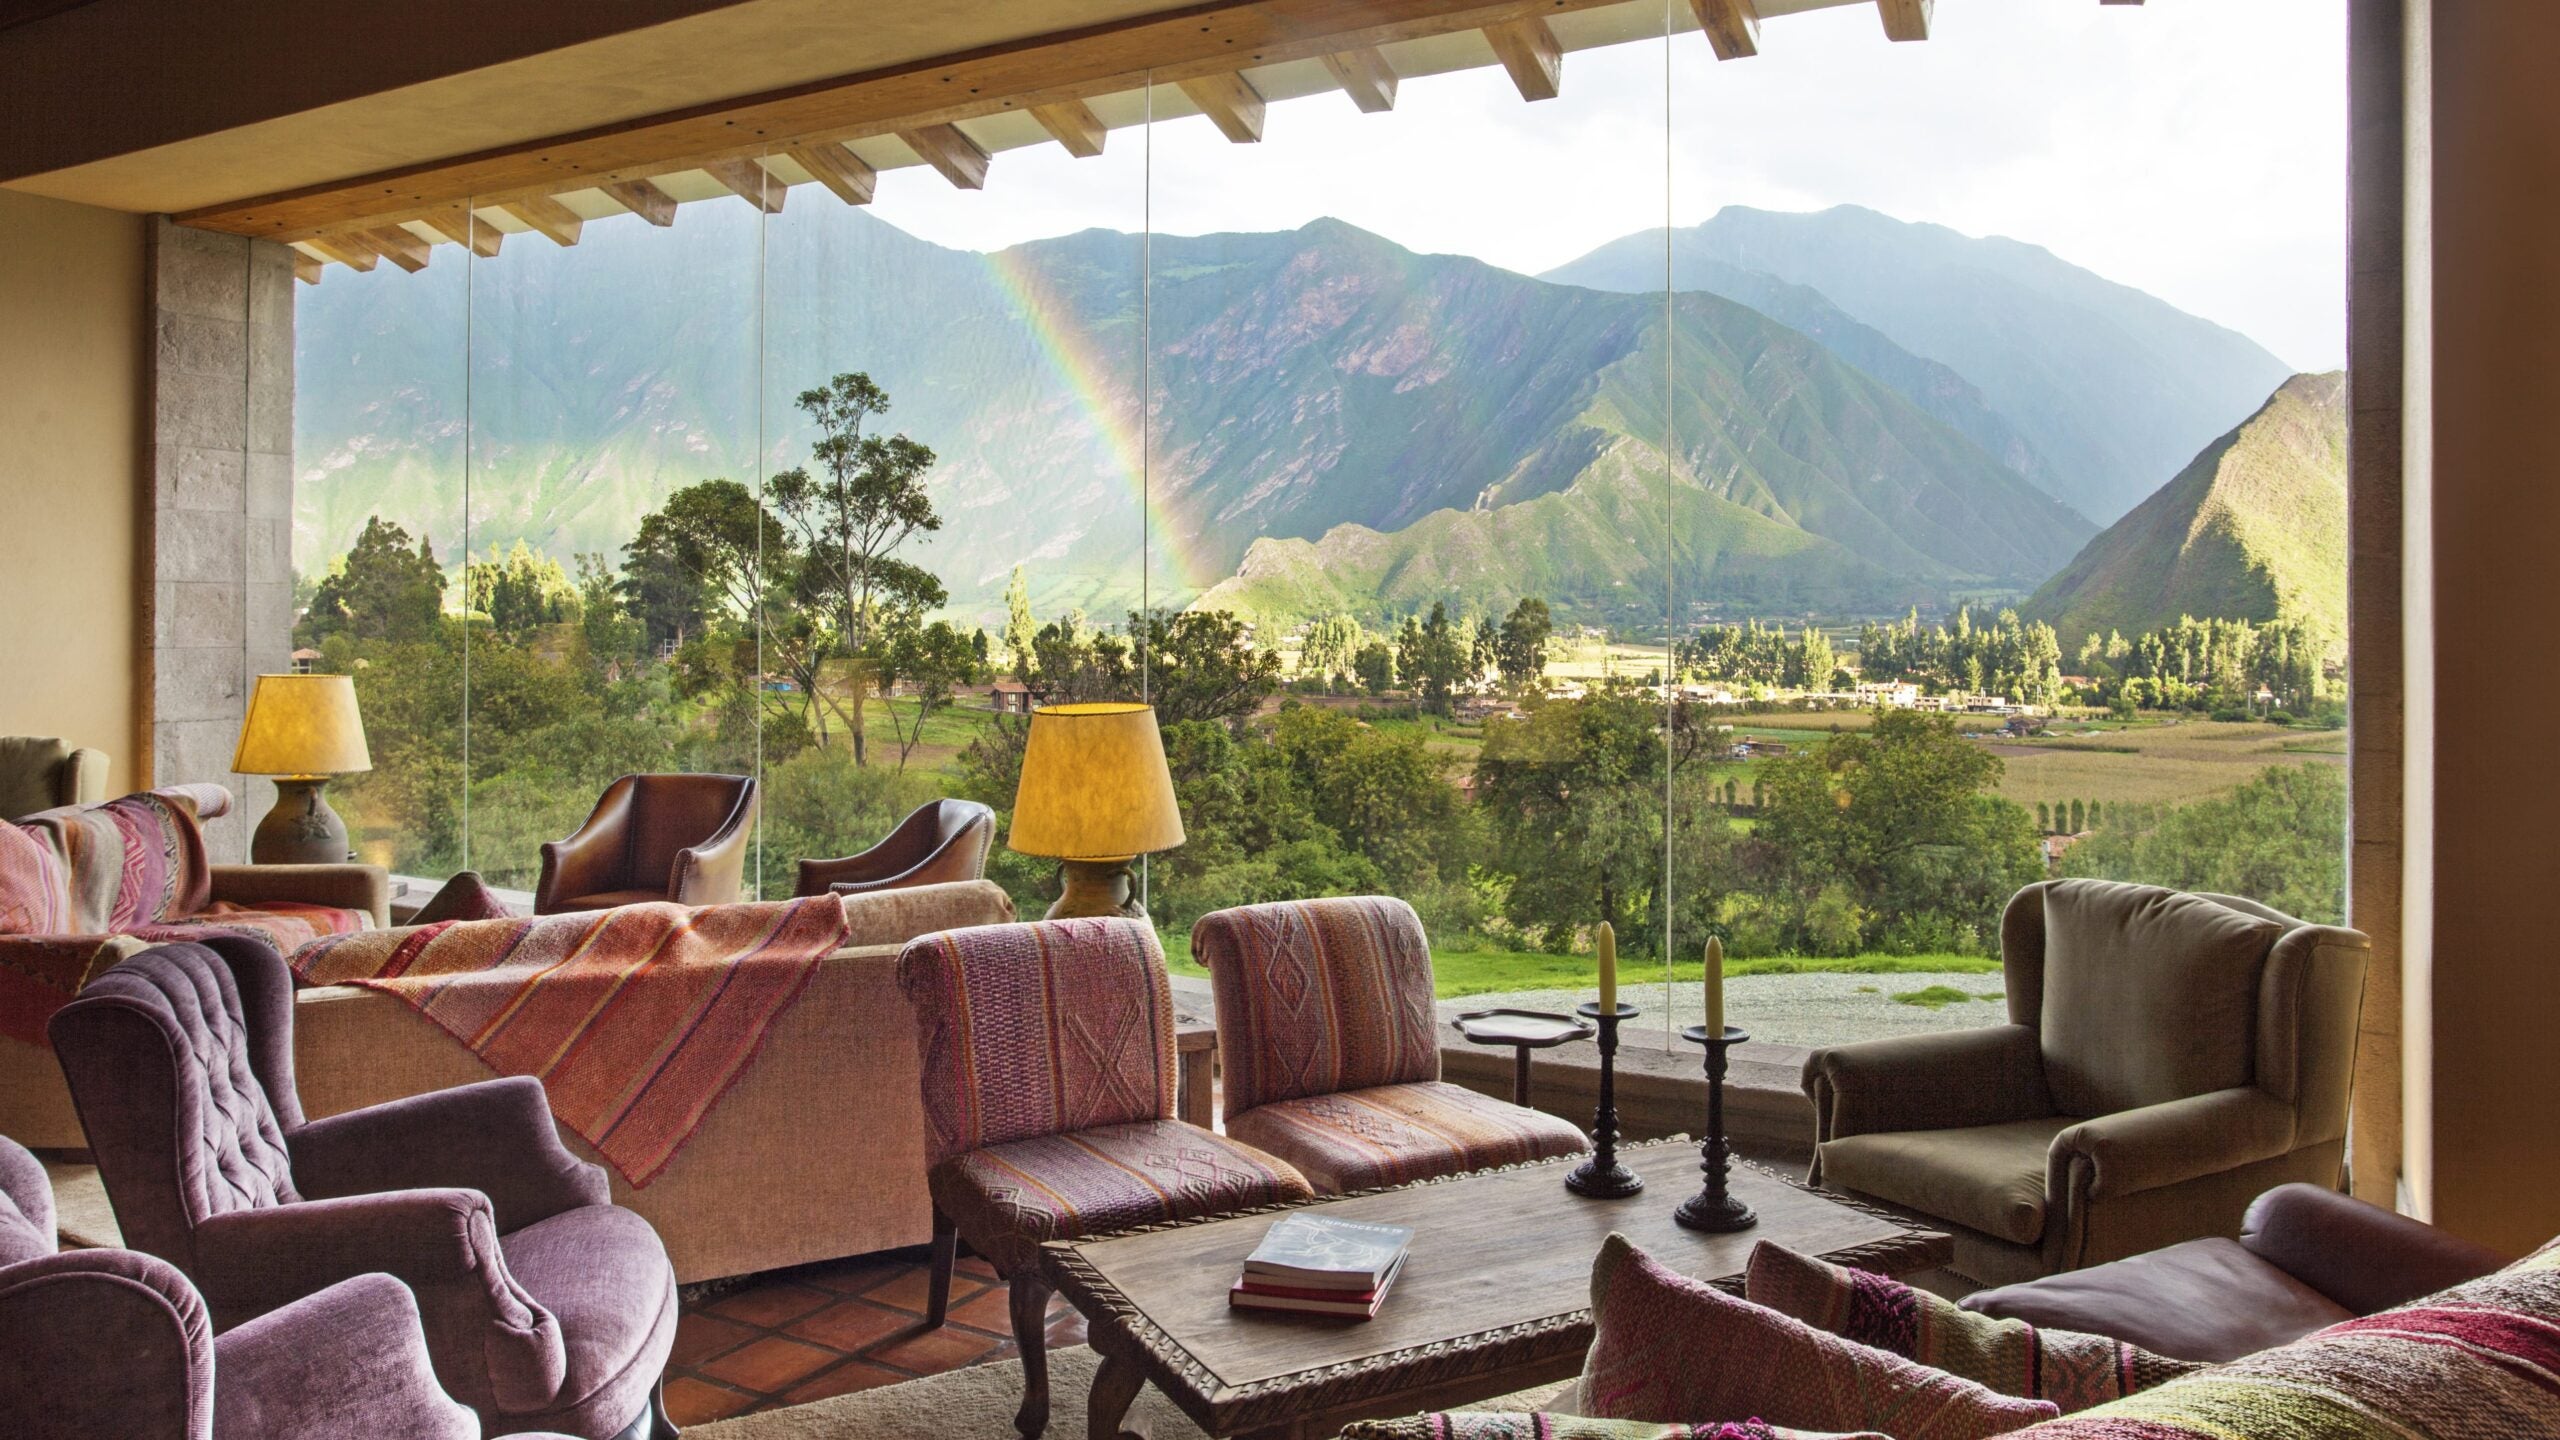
[51,940,676,1440]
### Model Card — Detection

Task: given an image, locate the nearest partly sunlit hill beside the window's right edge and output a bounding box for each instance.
[2022,372,2348,653]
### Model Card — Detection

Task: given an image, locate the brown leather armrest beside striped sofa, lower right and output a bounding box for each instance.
[2240,1184,2506,1314]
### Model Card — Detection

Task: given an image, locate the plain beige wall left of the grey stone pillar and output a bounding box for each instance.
[0,190,151,794]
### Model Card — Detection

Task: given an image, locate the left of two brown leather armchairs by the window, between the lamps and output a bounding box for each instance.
[532,774,755,915]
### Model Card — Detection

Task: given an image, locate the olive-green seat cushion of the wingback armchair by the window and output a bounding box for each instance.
[1823,1115,2071,1245]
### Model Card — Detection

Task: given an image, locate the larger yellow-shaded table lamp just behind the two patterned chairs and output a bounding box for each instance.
[1006,705,1183,920]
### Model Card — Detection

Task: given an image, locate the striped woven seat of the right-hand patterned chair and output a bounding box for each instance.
[1221,1076,1590,1194]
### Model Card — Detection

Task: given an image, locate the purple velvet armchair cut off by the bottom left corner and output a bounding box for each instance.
[0,1140,519,1440]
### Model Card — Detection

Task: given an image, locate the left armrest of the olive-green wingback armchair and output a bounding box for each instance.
[1805,1025,2053,1143]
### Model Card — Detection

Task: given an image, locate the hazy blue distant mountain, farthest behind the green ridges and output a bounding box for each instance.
[1546,205,2286,523]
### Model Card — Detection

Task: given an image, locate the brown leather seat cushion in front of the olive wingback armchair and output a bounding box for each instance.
[1964,1238,2353,1361]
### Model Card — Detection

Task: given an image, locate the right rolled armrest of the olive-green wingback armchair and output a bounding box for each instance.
[2045,1084,2294,1199]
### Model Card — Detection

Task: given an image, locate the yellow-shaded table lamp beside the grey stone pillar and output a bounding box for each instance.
[230,674,374,866]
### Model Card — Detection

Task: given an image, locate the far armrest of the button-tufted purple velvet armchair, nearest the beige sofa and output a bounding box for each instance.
[289,1076,612,1235]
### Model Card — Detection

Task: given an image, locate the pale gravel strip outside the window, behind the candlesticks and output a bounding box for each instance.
[1441,971,2010,1045]
